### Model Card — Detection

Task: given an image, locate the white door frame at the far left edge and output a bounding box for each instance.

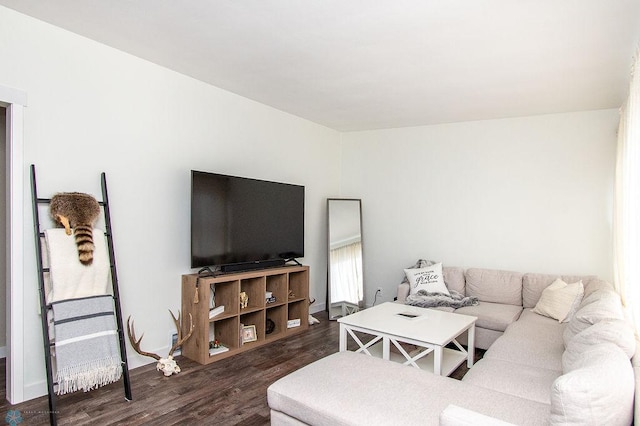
[0,85,27,404]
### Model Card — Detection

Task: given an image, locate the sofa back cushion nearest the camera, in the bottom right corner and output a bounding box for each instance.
[551,343,634,425]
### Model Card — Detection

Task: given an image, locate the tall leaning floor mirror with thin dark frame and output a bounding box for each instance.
[327,198,364,320]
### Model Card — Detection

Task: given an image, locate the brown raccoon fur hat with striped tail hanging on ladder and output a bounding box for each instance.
[49,192,100,265]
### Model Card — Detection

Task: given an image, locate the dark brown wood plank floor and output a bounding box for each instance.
[0,313,484,426]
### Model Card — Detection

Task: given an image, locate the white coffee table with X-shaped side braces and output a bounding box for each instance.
[338,302,477,376]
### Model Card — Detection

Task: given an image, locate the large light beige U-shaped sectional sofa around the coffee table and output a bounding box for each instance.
[267,268,640,425]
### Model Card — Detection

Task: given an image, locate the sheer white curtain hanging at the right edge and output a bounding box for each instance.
[614,51,640,331]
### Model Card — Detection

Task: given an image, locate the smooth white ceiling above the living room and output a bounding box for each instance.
[0,0,640,131]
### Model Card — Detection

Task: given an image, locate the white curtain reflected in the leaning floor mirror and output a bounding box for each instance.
[330,242,363,305]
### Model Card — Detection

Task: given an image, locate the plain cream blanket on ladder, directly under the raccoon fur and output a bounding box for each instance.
[44,228,110,303]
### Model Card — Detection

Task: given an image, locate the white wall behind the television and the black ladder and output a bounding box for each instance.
[0,7,340,399]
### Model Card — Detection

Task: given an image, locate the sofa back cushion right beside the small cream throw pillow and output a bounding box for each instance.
[564,290,624,347]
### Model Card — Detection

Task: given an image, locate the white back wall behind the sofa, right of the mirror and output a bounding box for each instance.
[341,110,618,303]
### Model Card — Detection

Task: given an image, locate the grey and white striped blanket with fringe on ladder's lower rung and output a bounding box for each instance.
[52,296,122,395]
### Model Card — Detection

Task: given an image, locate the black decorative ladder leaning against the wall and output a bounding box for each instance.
[31,164,132,426]
